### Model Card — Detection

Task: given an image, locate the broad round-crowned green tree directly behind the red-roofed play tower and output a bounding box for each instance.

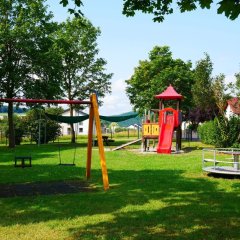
[126,46,193,113]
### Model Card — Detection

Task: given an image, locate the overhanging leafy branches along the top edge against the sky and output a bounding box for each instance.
[60,0,240,22]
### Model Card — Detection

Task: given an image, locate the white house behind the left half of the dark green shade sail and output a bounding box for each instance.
[60,109,89,135]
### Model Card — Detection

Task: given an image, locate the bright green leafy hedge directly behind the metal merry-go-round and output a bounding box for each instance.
[198,116,240,147]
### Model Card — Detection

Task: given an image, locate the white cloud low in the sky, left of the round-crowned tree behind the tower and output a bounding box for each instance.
[99,80,132,116]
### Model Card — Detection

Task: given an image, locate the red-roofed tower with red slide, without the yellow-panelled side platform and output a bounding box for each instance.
[155,85,183,154]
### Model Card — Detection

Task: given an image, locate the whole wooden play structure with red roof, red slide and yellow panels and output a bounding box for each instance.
[142,85,183,154]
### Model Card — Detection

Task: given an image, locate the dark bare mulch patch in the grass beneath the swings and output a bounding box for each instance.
[0,180,96,198]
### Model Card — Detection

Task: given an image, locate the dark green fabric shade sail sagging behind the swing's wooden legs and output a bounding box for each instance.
[45,113,138,124]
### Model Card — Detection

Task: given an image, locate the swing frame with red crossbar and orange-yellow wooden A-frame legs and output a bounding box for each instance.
[0,94,109,190]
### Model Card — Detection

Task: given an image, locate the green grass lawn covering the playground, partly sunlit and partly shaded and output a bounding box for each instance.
[0,139,240,240]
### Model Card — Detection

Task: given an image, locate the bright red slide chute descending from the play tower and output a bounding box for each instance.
[157,112,175,153]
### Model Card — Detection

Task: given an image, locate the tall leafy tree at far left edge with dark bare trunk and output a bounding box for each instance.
[0,0,55,147]
